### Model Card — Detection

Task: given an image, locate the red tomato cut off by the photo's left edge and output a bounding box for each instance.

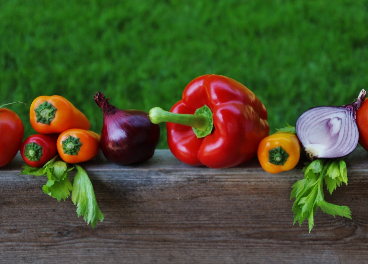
[0,108,24,167]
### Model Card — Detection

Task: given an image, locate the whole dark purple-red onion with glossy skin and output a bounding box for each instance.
[94,92,160,165]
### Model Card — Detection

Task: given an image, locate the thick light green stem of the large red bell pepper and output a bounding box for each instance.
[148,105,213,138]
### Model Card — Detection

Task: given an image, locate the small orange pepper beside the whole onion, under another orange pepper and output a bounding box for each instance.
[56,128,100,163]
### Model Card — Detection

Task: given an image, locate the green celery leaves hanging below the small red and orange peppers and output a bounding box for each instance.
[21,156,104,228]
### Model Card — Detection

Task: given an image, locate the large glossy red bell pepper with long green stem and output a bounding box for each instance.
[149,74,269,168]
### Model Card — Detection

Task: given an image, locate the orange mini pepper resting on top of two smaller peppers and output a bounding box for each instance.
[29,95,91,134]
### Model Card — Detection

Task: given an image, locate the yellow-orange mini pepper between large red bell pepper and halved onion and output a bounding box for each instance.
[257,132,300,173]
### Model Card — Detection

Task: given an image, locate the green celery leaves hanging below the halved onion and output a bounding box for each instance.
[290,159,351,232]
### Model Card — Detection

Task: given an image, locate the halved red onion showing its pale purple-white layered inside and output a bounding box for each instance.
[295,90,366,159]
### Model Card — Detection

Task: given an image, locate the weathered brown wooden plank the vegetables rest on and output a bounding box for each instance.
[0,149,368,263]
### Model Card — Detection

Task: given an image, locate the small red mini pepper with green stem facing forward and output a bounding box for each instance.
[20,134,57,167]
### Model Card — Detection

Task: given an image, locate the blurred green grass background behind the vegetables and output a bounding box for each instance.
[0,0,368,148]
